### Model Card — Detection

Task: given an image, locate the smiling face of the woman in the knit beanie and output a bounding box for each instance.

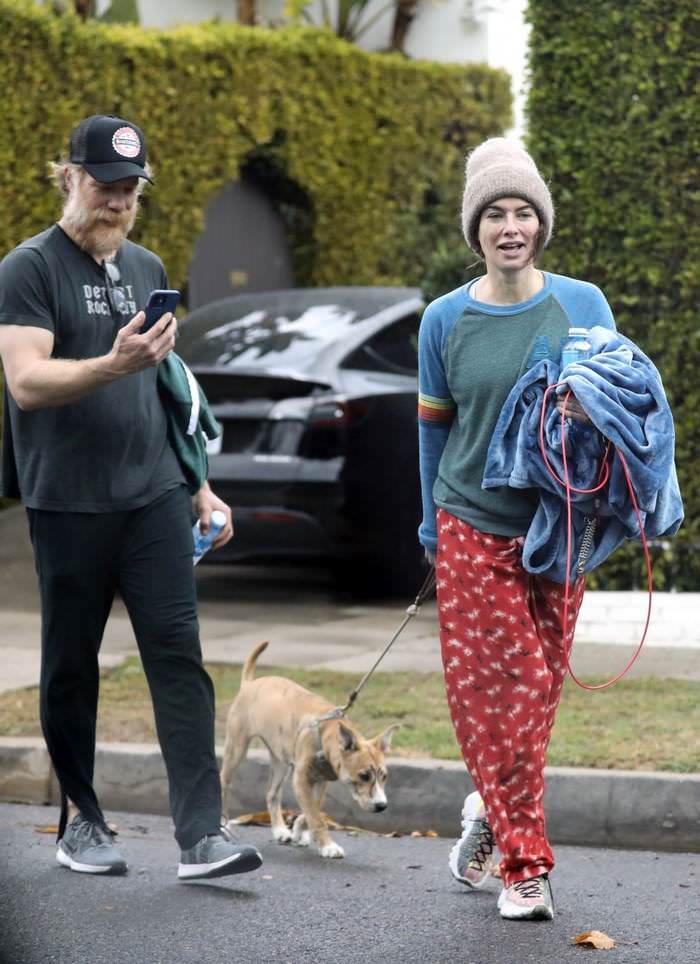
[479,197,540,271]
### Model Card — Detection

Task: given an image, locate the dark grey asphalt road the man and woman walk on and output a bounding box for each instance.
[0,805,700,964]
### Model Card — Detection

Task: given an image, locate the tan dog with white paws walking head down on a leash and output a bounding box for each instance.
[221,643,398,857]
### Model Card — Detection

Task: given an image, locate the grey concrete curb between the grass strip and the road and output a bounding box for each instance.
[0,737,700,853]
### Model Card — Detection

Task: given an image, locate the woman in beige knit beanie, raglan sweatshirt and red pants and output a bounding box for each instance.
[419,138,615,920]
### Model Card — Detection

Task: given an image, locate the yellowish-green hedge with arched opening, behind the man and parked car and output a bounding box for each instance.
[0,0,510,286]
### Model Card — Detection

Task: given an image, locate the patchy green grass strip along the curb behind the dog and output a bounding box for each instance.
[0,658,700,773]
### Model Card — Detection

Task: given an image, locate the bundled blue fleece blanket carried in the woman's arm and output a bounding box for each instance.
[482,327,683,583]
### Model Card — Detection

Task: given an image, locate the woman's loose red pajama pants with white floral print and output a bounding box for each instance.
[436,509,584,887]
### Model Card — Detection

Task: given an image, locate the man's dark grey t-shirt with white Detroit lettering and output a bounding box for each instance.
[0,225,184,512]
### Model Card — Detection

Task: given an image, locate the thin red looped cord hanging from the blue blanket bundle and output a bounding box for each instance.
[540,382,654,690]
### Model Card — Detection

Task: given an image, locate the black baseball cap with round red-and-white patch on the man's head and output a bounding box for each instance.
[69,114,152,184]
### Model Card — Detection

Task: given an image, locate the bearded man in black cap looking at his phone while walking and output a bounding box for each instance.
[0,115,262,880]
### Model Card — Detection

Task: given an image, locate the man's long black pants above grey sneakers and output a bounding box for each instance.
[27,486,221,849]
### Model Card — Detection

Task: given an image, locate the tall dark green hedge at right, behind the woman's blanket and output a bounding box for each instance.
[528,0,700,591]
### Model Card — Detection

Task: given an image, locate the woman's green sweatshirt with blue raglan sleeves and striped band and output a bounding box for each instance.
[418,272,615,550]
